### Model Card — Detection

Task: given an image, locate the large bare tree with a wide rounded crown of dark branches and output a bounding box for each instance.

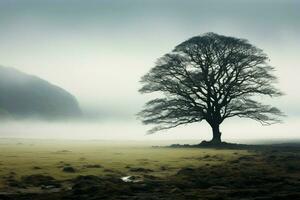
[139,33,282,143]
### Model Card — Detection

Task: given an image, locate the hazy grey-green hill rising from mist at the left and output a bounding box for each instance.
[0,66,81,119]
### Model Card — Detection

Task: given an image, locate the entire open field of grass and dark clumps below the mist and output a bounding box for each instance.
[0,140,300,199]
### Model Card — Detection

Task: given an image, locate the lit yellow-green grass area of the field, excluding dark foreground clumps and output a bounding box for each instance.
[0,140,250,181]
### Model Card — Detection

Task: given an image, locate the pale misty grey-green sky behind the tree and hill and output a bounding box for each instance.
[0,0,300,139]
